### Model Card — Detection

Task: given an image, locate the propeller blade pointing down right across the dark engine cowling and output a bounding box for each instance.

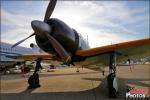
[46,33,71,63]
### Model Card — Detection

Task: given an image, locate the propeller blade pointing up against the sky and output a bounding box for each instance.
[44,0,57,22]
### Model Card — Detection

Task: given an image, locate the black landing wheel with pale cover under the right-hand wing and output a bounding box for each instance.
[107,73,118,98]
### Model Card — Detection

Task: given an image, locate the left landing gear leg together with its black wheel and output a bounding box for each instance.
[28,58,42,88]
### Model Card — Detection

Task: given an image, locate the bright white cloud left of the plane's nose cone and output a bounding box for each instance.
[1,9,42,47]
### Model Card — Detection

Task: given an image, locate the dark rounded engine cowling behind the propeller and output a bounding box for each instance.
[35,18,79,54]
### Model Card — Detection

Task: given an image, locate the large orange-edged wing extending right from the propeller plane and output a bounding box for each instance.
[74,38,150,65]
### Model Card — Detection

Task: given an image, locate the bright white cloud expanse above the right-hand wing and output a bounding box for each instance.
[53,1,148,47]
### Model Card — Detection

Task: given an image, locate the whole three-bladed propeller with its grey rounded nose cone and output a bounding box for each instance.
[12,0,71,64]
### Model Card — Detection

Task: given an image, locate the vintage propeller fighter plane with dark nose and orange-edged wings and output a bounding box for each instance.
[12,0,150,98]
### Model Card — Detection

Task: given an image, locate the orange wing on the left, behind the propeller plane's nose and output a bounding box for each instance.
[7,53,53,61]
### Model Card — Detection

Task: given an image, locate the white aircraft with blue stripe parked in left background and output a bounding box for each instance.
[0,42,45,67]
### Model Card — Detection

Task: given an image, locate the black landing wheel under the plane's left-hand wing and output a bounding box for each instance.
[28,73,40,88]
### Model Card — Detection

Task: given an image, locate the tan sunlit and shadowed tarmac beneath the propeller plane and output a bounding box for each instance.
[0,65,150,100]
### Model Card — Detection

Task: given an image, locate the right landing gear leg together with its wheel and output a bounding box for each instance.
[107,52,118,98]
